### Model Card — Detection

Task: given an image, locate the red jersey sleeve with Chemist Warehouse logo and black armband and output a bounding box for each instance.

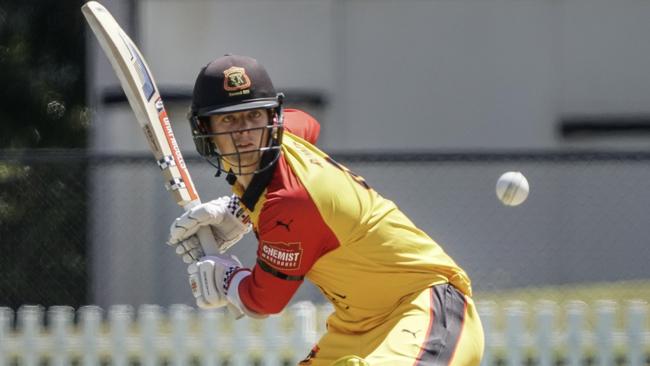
[234,160,339,314]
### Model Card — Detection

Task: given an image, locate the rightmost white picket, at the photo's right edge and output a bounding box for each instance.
[626,300,648,366]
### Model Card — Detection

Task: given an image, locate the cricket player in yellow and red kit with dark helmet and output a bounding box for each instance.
[169,55,484,366]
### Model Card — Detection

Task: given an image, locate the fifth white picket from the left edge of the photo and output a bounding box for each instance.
[108,305,133,366]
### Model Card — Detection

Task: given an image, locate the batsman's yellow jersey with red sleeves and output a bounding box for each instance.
[233,109,471,333]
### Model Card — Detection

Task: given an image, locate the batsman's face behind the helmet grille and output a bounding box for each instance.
[210,109,269,173]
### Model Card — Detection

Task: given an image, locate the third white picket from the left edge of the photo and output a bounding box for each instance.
[47,306,74,366]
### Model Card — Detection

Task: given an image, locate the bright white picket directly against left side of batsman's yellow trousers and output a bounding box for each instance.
[289,301,316,365]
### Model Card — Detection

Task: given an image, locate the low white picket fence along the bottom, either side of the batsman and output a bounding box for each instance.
[0,300,650,366]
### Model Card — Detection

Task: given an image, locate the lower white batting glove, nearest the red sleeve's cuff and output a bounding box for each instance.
[187,256,250,309]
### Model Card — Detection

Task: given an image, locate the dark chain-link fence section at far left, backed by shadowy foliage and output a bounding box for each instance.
[0,152,89,307]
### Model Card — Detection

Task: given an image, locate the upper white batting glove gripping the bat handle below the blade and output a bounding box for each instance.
[167,195,251,264]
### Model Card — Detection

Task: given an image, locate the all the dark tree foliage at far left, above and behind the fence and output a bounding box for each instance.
[0,0,88,307]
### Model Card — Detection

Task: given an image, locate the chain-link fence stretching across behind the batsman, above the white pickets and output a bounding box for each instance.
[0,151,650,308]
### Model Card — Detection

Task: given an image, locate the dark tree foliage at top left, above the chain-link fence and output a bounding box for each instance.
[0,0,87,148]
